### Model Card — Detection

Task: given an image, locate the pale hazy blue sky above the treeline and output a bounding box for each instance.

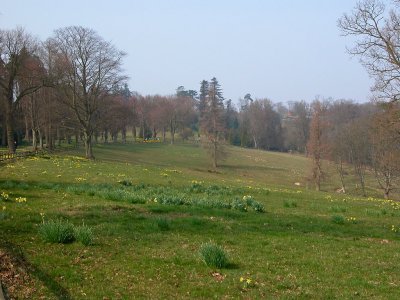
[0,0,372,102]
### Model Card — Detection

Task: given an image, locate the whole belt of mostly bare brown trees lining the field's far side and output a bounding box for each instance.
[0,1,400,197]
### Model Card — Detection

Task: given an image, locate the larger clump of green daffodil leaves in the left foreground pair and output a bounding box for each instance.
[39,220,75,244]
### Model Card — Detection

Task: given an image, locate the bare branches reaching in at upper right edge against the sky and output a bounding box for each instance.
[338,0,400,101]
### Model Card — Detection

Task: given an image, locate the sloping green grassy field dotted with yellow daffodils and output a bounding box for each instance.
[0,144,400,299]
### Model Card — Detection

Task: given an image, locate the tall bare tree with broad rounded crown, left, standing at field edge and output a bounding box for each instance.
[49,26,125,159]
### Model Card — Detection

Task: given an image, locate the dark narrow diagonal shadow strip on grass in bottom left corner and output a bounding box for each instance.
[0,241,72,300]
